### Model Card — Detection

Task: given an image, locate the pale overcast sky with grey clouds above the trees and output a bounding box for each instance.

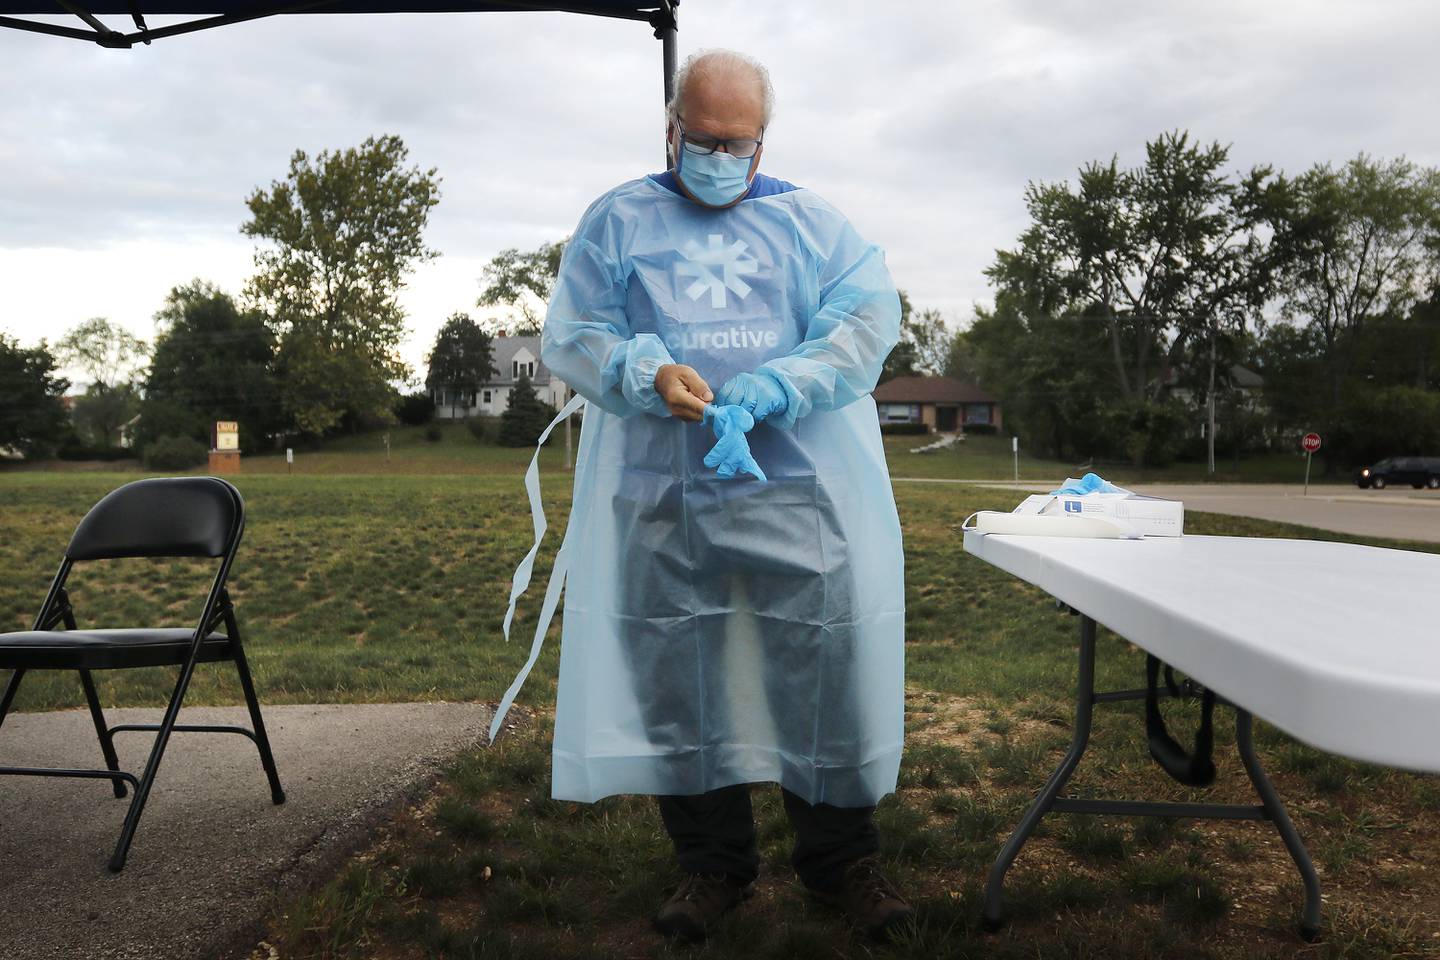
[0,0,1440,385]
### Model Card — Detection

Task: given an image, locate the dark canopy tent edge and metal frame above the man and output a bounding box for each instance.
[0,0,680,104]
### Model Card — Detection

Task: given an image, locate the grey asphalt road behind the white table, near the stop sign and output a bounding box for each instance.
[896,478,1440,543]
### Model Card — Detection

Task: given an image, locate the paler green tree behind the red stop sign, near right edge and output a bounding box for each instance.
[1284,154,1440,471]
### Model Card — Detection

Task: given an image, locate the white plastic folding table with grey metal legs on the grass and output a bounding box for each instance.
[965,531,1440,940]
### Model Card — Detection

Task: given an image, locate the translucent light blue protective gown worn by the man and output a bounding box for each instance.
[541,177,904,806]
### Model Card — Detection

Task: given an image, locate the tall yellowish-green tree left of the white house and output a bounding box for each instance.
[240,135,439,435]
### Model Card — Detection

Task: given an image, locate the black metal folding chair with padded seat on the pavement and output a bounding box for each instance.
[0,476,285,872]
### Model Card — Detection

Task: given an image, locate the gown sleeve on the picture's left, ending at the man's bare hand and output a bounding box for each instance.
[540,197,674,417]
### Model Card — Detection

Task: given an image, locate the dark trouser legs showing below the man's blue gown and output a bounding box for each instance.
[657,783,880,891]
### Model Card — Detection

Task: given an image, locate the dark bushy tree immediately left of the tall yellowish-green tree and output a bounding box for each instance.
[137,279,284,450]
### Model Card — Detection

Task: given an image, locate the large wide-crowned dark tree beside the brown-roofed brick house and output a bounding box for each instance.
[986,131,1283,469]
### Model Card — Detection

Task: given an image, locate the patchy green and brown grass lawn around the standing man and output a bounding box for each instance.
[0,457,1440,960]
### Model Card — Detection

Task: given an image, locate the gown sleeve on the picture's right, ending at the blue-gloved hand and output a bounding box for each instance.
[759,203,900,427]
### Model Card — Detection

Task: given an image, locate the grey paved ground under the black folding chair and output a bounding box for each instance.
[0,704,491,960]
